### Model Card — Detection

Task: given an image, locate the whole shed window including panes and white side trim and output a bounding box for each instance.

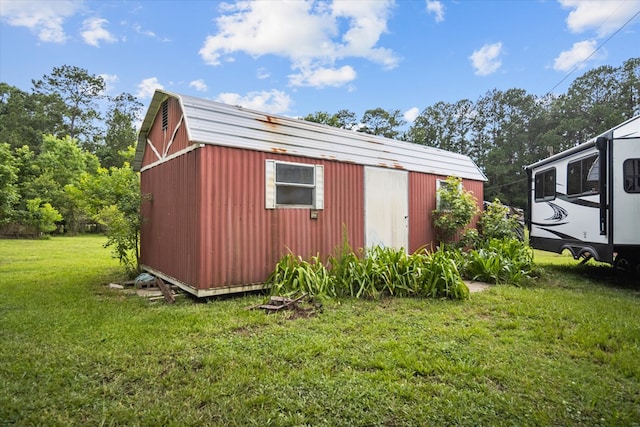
[265,160,324,209]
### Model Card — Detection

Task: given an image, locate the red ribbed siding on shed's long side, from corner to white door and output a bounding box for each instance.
[197,145,364,289]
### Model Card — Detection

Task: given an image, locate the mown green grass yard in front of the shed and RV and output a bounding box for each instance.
[0,236,640,426]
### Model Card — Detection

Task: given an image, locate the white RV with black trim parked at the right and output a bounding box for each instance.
[525,116,640,272]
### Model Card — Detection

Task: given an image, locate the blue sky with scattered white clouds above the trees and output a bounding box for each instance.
[0,0,640,123]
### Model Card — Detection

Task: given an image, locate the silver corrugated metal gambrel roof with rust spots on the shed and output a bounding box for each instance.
[134,90,487,181]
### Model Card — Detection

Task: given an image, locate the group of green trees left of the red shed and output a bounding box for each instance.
[0,65,142,269]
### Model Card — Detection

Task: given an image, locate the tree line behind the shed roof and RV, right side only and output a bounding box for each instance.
[304,58,640,208]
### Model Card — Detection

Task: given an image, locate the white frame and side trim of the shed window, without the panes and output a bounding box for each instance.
[265,160,324,210]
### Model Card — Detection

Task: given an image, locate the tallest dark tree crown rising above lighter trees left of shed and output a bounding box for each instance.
[32,65,106,149]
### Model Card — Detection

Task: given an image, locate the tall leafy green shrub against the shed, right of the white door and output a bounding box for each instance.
[431,176,478,243]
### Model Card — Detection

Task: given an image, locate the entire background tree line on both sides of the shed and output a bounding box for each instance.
[0,58,640,247]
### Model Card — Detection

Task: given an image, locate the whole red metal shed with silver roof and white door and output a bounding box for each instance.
[134,90,486,297]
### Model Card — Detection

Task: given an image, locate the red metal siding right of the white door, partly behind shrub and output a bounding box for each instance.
[409,172,484,253]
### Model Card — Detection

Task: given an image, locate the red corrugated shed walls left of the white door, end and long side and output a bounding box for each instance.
[141,145,364,290]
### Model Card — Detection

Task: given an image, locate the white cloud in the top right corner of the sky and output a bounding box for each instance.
[559,0,640,38]
